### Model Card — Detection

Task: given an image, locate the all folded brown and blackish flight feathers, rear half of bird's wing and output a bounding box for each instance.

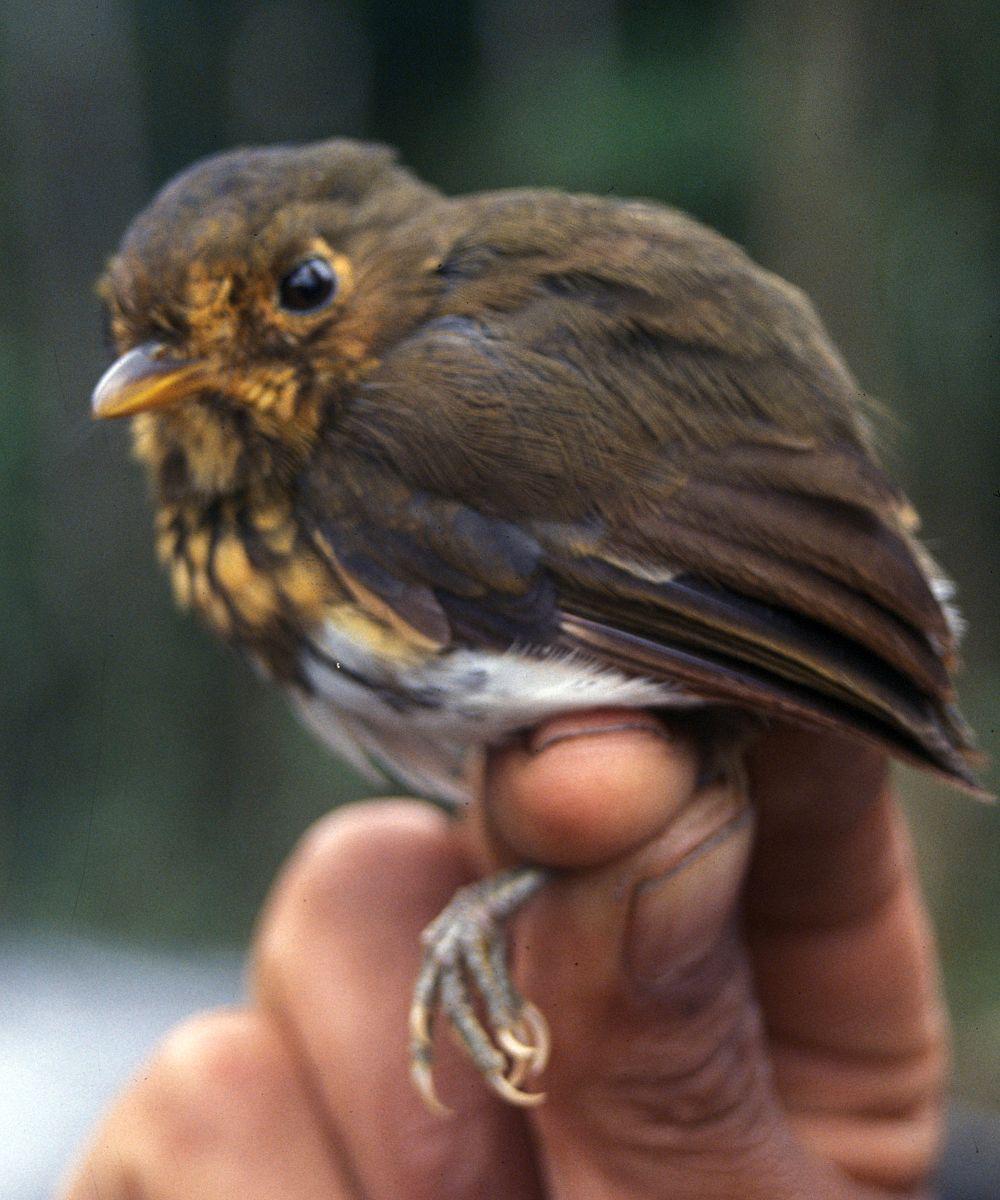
[545,446,974,786]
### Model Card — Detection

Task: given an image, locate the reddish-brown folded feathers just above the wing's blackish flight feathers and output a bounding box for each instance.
[588,456,954,698]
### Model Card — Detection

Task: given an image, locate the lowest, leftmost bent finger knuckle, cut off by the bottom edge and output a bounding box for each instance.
[61,1012,360,1200]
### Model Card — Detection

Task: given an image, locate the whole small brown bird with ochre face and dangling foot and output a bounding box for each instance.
[92,139,978,1106]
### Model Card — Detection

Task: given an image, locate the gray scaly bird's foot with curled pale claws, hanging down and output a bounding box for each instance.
[409,866,549,1112]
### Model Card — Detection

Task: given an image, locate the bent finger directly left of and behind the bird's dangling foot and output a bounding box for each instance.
[255,802,539,1200]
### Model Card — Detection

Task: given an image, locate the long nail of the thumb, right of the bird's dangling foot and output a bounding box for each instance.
[624,808,753,989]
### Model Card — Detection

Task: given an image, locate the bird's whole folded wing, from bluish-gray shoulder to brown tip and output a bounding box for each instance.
[302,439,975,786]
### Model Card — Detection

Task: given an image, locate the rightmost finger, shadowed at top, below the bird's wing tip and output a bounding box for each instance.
[748,731,947,1188]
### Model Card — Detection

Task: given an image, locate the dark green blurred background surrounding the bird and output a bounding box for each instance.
[0,0,1000,1103]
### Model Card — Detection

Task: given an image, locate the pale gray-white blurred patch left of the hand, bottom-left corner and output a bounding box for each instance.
[0,937,241,1200]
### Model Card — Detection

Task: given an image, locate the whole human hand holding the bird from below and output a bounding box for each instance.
[64,713,947,1200]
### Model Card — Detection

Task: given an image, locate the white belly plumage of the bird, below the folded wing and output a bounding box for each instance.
[288,622,699,804]
